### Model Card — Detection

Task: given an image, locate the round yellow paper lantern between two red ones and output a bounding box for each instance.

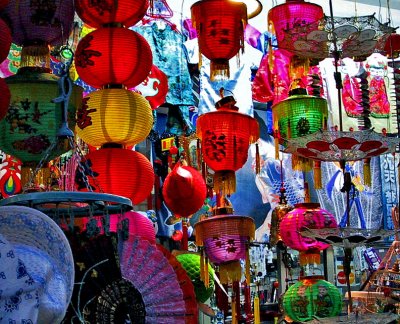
[76,89,153,146]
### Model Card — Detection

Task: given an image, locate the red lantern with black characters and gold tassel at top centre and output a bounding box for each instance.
[191,0,247,80]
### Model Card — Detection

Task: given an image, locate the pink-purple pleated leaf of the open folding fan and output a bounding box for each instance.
[121,238,186,324]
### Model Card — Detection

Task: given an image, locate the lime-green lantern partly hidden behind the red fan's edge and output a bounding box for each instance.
[176,253,214,303]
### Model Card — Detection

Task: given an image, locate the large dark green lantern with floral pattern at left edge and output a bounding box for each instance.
[0,68,82,165]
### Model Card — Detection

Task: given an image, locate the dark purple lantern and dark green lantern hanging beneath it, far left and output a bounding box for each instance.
[0,0,82,167]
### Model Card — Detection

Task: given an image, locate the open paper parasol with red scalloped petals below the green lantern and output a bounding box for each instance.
[284,129,400,162]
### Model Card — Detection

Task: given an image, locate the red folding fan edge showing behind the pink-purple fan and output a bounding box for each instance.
[157,244,199,324]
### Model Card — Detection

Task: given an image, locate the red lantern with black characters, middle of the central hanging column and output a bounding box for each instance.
[196,96,260,195]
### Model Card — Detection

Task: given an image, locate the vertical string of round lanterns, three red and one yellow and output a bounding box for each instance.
[75,0,154,204]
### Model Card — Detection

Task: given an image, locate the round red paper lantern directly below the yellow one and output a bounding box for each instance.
[76,148,154,204]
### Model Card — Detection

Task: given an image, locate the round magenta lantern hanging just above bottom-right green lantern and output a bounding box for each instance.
[280,203,337,251]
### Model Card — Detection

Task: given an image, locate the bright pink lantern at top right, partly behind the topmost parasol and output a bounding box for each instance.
[268,0,324,46]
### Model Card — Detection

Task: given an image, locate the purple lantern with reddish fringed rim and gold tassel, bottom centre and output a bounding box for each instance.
[194,215,255,283]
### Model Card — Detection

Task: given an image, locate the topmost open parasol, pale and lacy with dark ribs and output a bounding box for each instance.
[278,15,395,60]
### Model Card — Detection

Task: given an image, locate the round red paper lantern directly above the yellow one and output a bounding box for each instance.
[75,27,153,88]
